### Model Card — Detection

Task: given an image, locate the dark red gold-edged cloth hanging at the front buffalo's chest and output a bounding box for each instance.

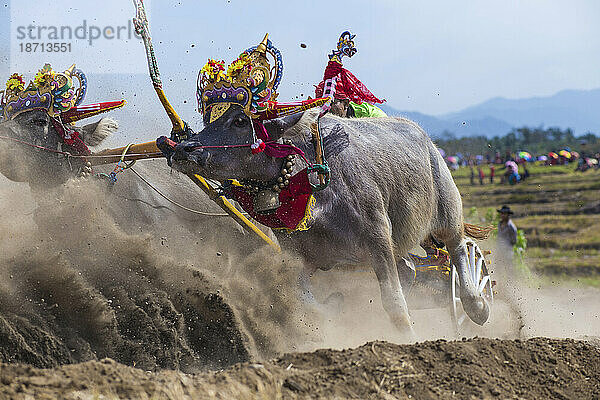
[231,169,316,231]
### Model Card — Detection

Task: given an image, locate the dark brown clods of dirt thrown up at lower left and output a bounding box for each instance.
[0,231,250,371]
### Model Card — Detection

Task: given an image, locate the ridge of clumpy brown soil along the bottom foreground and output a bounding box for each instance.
[0,338,600,399]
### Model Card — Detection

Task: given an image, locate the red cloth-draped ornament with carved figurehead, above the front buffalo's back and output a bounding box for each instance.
[315,31,385,104]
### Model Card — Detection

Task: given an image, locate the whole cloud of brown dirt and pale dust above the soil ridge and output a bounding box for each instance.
[0,173,600,372]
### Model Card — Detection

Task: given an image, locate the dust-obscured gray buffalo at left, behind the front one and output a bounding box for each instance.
[0,110,240,237]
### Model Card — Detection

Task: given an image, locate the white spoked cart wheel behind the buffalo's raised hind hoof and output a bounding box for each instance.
[450,240,494,333]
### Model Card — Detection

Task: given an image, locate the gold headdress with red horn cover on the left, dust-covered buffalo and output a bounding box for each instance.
[0,64,125,122]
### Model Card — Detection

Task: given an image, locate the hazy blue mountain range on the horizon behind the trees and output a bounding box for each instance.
[382,89,600,137]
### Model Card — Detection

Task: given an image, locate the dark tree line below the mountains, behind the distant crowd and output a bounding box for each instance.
[433,126,600,155]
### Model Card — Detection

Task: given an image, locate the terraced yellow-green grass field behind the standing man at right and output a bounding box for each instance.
[453,165,600,278]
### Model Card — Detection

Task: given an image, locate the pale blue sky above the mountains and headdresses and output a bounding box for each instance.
[0,0,600,114]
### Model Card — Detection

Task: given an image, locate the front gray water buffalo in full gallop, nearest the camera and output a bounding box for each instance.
[170,105,489,333]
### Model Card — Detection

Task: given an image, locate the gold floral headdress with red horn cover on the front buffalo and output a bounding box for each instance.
[197,34,328,123]
